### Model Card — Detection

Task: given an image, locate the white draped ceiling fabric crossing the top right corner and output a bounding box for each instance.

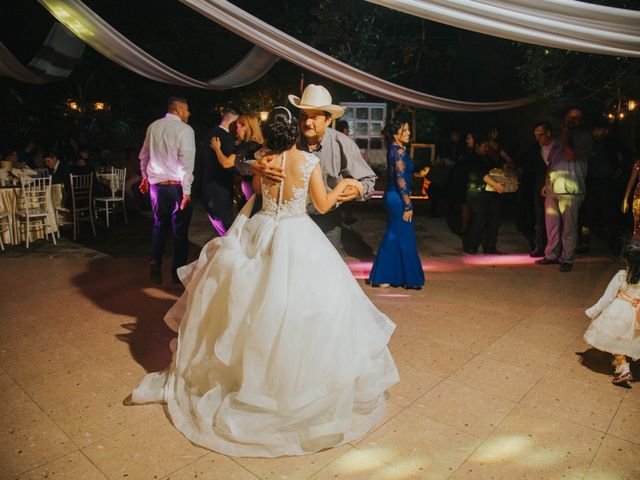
[366,0,640,57]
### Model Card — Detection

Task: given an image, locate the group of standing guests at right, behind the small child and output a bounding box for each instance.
[430,107,640,272]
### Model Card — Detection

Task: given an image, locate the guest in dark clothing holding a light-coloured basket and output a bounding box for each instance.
[462,139,504,254]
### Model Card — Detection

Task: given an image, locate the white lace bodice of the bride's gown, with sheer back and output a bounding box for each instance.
[259,152,319,218]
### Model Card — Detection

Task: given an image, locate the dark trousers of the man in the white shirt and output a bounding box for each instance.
[151,184,191,272]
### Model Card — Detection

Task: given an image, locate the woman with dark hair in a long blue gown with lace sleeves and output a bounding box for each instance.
[369,119,424,289]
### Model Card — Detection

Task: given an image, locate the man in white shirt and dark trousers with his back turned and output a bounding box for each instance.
[139,97,196,284]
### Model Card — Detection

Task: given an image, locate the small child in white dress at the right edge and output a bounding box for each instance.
[584,240,640,385]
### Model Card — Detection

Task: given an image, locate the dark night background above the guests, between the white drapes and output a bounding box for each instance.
[0,0,640,161]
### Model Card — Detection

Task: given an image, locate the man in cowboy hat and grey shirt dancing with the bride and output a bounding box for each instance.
[254,84,376,249]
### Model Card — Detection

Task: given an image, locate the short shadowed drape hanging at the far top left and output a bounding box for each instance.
[0,22,84,84]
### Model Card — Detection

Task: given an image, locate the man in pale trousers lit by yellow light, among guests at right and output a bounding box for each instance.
[536,108,593,272]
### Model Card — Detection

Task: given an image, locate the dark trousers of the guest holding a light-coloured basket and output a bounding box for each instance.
[462,190,500,253]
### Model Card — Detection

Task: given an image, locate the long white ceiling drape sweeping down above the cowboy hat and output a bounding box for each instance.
[180,0,531,112]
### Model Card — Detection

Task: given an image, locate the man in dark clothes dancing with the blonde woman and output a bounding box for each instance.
[202,108,238,236]
